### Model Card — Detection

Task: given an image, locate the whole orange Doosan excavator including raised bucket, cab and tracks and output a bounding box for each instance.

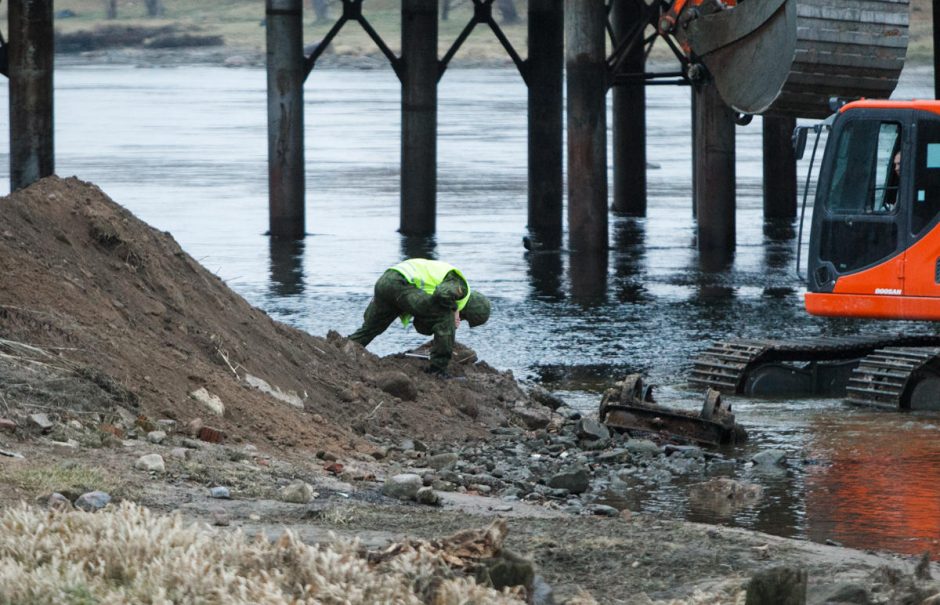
[659,0,940,410]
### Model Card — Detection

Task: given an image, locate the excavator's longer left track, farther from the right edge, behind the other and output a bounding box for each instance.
[689,335,940,394]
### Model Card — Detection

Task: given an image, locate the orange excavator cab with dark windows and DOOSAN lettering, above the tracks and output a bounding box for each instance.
[806,101,940,320]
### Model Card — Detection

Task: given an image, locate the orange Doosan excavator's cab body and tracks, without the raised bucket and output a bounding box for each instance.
[690,100,940,410]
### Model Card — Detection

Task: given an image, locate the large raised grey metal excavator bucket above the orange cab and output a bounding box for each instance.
[685,0,910,118]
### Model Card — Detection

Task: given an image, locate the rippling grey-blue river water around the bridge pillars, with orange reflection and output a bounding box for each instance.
[0,60,940,556]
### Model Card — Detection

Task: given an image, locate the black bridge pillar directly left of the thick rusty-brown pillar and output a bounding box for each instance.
[525,0,565,249]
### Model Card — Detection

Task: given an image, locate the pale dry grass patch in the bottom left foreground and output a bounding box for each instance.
[0,503,522,605]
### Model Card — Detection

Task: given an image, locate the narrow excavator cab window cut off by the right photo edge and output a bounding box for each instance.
[911,118,940,237]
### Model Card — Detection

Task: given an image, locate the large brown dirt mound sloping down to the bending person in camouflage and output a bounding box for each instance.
[0,177,526,451]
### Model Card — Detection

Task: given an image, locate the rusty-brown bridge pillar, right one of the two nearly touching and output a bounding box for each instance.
[565,0,607,253]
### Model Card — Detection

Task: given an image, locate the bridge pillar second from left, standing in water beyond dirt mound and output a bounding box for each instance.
[265,0,306,239]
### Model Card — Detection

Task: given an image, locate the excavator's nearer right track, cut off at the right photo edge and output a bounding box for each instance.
[846,347,940,410]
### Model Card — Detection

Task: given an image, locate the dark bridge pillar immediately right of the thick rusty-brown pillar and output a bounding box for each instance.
[611,0,646,216]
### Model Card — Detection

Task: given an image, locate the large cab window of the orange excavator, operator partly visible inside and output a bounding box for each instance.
[817,119,902,276]
